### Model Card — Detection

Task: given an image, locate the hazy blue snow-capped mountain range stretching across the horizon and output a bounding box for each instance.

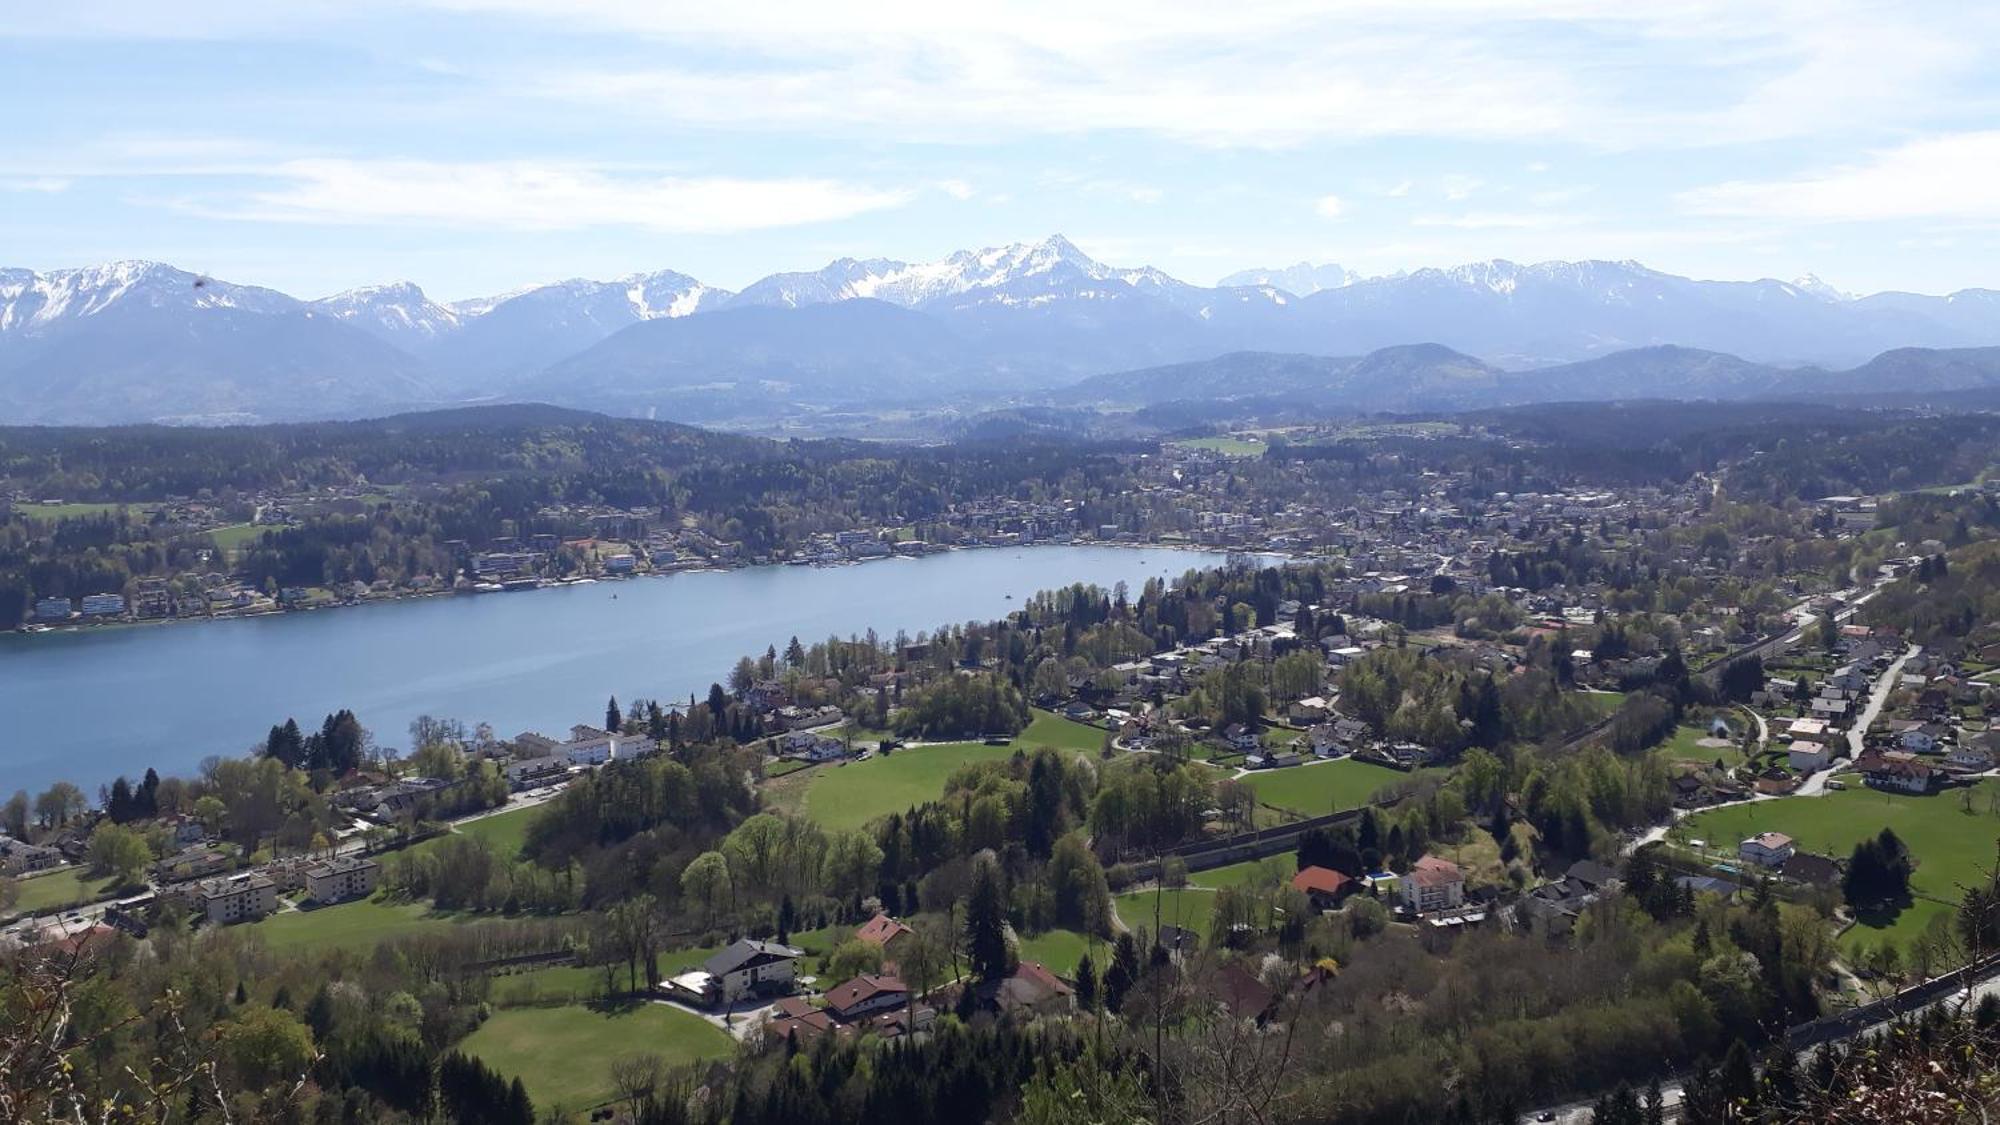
[0,236,2000,424]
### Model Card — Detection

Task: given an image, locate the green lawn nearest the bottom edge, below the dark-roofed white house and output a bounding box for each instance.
[460,1003,736,1117]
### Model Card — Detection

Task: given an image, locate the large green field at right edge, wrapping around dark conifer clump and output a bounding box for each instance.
[1676,781,2000,953]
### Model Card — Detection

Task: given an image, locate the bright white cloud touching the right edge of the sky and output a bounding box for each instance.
[1678,130,2000,222]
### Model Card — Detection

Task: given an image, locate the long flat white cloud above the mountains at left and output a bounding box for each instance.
[182,158,912,234]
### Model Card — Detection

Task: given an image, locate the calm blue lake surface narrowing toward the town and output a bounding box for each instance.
[0,546,1224,799]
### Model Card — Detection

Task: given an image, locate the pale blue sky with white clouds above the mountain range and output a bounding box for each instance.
[0,0,2000,300]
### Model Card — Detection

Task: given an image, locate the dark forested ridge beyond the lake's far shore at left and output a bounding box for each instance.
[0,404,788,500]
